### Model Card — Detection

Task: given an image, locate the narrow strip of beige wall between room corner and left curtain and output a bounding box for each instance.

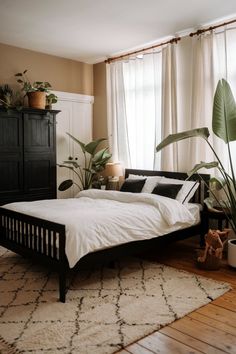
[93,63,107,145]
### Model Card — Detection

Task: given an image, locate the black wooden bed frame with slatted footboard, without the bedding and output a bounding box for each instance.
[0,169,210,302]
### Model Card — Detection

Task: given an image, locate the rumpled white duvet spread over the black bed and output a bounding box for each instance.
[4,189,199,268]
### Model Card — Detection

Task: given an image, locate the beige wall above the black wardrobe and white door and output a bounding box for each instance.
[0,43,93,95]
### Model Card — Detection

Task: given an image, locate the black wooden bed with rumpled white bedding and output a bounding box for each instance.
[0,169,210,302]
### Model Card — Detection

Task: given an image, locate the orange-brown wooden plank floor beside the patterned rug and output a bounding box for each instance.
[119,238,236,354]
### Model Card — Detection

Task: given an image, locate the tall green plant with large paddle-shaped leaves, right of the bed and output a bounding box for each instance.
[156,79,236,232]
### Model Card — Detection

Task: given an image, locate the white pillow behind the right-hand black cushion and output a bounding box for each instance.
[159,177,199,203]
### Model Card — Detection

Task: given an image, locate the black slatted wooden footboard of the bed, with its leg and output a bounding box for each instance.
[0,208,69,302]
